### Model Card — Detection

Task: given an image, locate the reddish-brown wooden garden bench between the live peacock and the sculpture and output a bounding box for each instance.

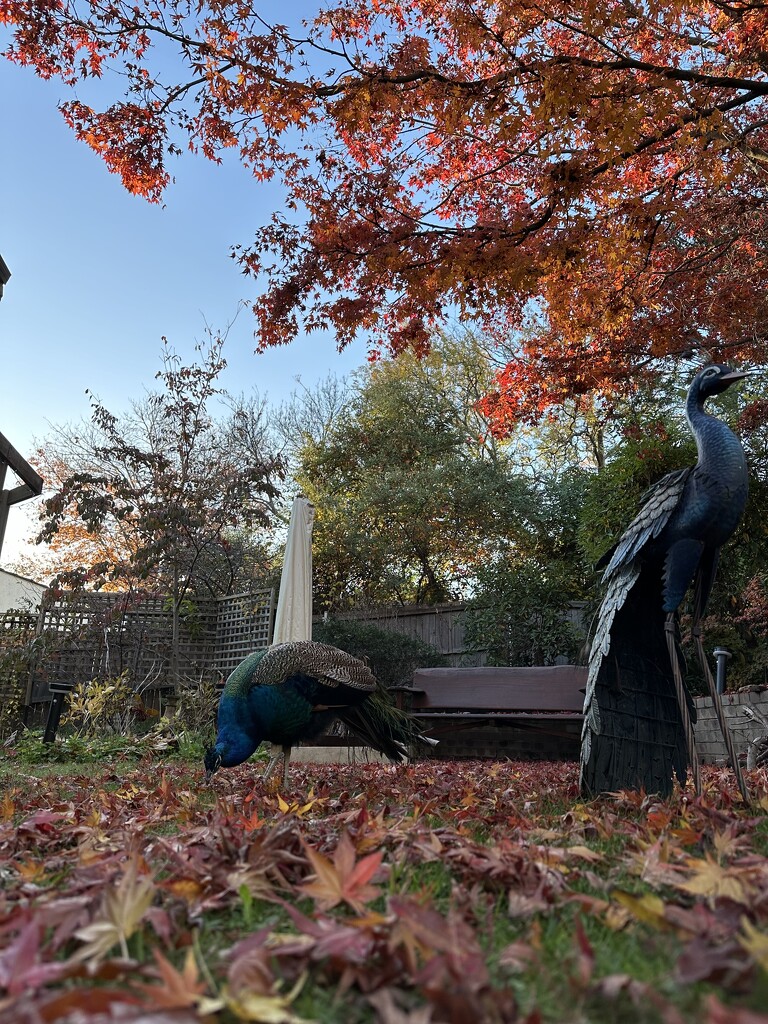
[398,665,587,757]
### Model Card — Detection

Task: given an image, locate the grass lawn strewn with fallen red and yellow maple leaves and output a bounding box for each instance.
[0,759,768,1024]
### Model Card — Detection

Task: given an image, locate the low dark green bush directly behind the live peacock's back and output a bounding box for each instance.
[312,618,447,687]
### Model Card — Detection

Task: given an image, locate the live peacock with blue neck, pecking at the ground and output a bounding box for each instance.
[204,640,435,784]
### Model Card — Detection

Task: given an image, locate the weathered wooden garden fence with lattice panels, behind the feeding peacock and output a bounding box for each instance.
[0,590,581,737]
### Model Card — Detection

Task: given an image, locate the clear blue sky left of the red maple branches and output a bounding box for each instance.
[0,46,366,563]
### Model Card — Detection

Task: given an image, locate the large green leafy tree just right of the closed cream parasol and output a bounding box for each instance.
[298,338,535,610]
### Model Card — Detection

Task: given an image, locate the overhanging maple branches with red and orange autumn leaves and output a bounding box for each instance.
[0,0,768,419]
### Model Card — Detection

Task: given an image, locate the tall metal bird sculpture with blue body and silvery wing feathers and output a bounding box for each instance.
[581,364,749,803]
